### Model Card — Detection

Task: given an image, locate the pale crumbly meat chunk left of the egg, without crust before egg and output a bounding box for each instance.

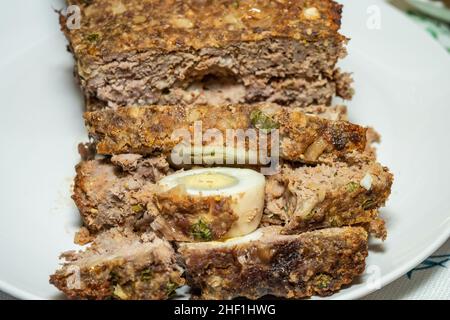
[72,155,172,233]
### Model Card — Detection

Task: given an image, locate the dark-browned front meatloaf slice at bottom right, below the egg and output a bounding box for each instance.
[178,227,368,299]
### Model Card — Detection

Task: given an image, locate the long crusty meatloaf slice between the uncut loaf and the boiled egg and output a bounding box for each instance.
[85,104,367,163]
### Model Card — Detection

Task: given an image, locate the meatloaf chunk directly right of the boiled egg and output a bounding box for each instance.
[262,162,393,237]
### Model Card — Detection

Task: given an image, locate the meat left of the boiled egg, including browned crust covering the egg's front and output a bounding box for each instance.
[72,158,243,243]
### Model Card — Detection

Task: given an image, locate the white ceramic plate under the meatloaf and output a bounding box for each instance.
[0,0,450,299]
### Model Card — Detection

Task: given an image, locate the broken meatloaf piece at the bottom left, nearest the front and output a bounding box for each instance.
[50,228,184,300]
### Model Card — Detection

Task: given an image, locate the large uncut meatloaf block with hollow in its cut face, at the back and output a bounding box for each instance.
[61,0,352,109]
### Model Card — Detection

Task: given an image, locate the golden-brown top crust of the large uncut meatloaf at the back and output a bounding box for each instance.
[61,0,345,61]
